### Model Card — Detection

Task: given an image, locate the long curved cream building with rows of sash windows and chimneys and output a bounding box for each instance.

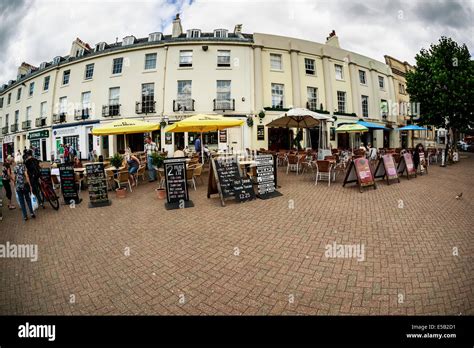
[0,16,399,160]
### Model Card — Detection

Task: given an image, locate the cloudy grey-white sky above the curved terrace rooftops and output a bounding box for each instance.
[0,0,474,83]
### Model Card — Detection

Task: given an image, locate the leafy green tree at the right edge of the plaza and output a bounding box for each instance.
[406,36,474,143]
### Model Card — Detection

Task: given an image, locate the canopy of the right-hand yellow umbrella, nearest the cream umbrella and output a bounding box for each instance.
[165,114,244,133]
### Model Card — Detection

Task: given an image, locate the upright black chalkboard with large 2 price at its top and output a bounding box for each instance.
[163,157,194,210]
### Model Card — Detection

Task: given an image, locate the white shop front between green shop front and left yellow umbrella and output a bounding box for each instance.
[52,121,100,160]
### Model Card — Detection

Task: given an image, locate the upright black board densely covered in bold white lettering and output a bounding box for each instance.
[255,154,282,199]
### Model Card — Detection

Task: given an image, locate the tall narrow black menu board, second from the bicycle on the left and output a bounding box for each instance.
[86,162,111,208]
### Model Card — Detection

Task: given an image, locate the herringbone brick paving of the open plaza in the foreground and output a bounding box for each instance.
[0,155,474,315]
